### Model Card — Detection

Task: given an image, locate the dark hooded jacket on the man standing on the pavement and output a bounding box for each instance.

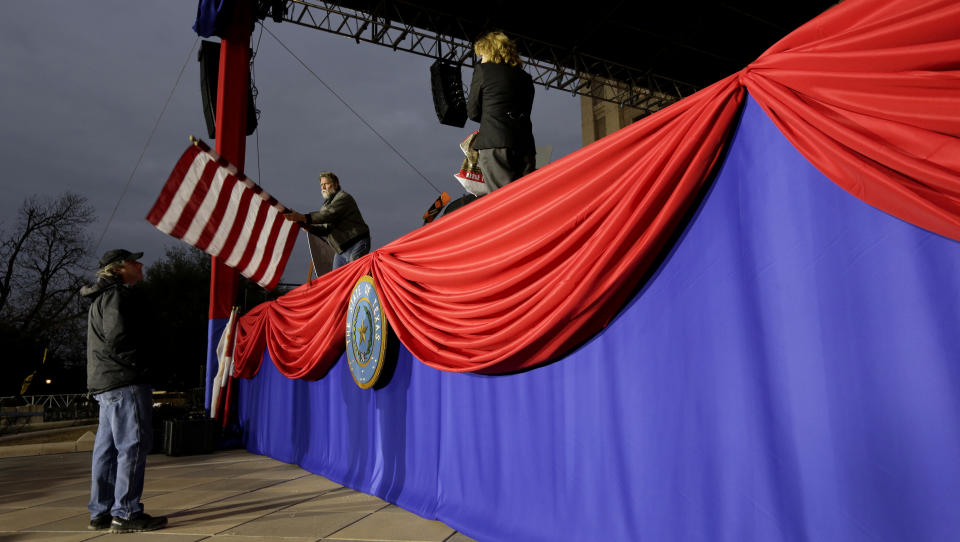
[80,277,147,394]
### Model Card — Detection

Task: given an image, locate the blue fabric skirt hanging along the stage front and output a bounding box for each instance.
[239,95,960,541]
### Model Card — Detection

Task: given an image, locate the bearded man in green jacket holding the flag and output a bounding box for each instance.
[285,171,370,269]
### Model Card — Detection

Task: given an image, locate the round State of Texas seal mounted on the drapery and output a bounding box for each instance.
[347,275,387,389]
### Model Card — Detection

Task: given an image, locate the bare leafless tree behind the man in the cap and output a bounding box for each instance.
[0,192,95,394]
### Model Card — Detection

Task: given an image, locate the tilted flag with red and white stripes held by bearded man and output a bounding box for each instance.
[147,140,299,290]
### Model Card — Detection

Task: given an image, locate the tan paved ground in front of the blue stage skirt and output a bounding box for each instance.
[0,450,472,542]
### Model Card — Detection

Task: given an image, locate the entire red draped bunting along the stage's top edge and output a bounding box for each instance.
[236,0,960,378]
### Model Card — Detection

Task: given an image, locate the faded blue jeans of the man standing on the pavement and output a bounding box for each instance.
[88,385,153,519]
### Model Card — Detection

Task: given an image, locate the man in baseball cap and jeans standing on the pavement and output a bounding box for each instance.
[80,249,167,533]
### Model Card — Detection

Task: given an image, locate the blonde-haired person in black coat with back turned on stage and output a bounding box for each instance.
[467,32,537,191]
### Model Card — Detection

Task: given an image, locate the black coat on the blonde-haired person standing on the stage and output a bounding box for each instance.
[467,62,537,154]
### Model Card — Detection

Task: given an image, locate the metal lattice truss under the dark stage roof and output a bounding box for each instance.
[261,0,699,113]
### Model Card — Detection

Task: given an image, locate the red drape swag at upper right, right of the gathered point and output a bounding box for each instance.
[740,0,960,240]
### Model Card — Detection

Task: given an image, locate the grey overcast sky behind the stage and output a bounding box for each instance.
[0,0,581,283]
